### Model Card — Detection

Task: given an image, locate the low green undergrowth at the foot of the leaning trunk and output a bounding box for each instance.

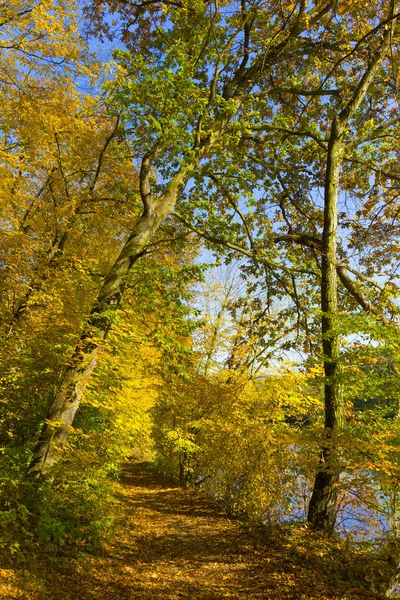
[0,469,115,555]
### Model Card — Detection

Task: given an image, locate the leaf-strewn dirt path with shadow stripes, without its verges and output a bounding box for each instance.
[104,468,291,600]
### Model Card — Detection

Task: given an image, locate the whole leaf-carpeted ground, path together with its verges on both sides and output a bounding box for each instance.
[0,464,392,600]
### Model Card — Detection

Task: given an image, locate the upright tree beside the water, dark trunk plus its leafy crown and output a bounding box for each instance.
[169,2,399,531]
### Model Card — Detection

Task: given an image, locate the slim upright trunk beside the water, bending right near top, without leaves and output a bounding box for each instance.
[308,2,395,531]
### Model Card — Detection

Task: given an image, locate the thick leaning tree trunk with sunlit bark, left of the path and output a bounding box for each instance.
[28,165,193,476]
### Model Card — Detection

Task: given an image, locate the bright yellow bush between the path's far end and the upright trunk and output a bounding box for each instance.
[155,371,322,521]
